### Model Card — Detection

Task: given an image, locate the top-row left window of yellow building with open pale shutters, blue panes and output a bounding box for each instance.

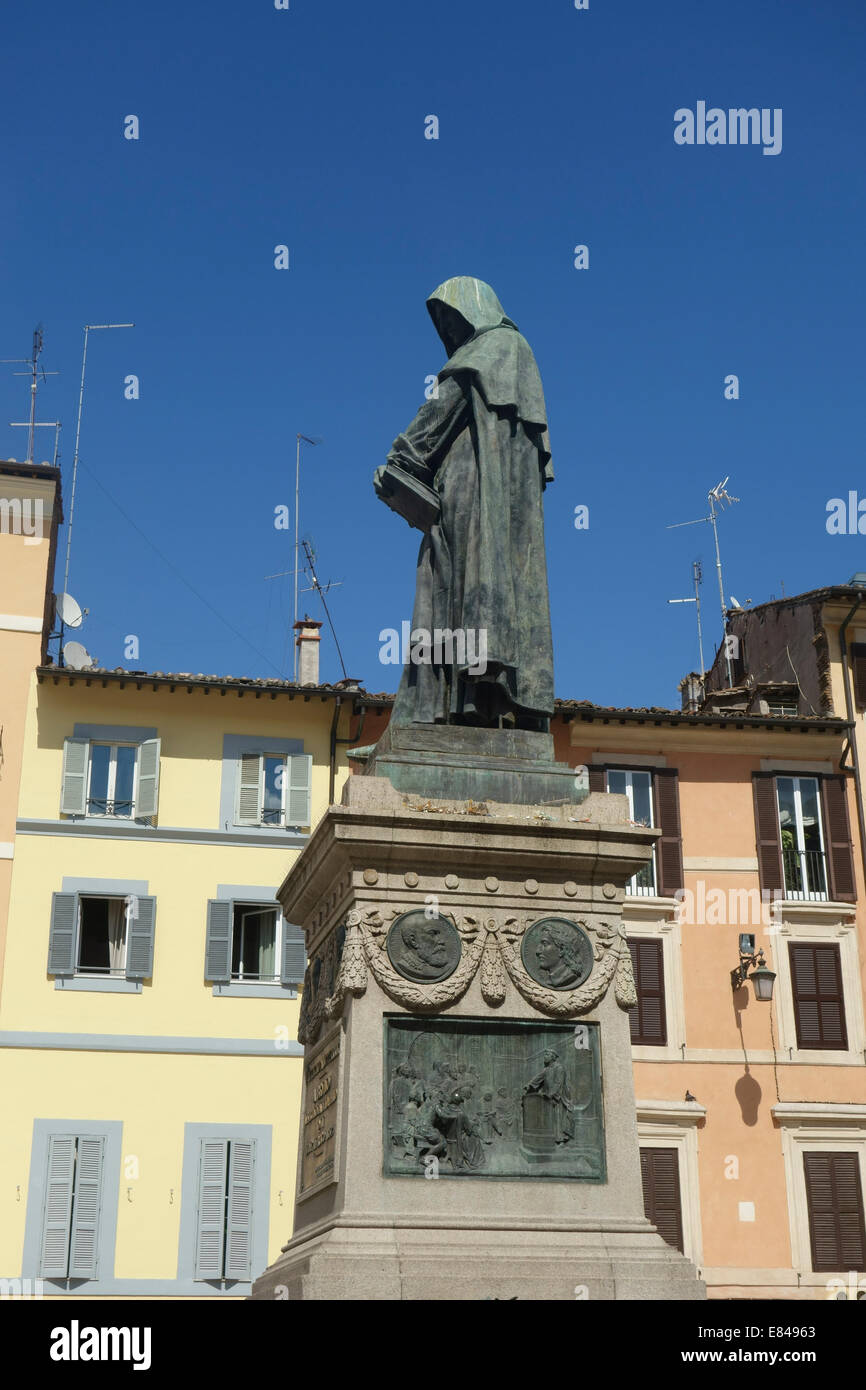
[60,738,160,820]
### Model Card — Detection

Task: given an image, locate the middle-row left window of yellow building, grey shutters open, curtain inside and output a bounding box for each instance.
[47,892,156,980]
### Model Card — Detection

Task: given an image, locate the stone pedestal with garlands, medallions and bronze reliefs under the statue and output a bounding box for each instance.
[253,776,705,1300]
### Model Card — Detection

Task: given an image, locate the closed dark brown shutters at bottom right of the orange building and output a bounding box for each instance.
[803,1154,866,1273]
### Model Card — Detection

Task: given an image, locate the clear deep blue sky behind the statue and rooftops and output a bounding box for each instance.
[0,0,866,705]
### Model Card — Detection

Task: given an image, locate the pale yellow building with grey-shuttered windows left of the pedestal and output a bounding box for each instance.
[0,464,389,1298]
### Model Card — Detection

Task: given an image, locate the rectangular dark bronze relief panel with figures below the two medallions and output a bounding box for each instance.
[384,1015,606,1183]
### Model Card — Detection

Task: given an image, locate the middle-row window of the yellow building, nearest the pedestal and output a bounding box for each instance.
[204,898,307,992]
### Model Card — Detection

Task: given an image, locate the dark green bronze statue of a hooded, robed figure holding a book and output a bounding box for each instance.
[374,275,553,733]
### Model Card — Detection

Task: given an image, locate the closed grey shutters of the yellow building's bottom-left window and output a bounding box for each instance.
[39,1134,106,1279]
